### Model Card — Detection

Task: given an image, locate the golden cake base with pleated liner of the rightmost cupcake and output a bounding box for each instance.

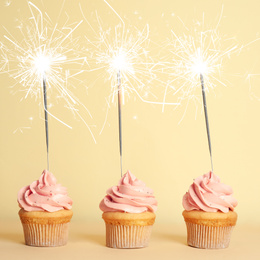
[182,210,237,249]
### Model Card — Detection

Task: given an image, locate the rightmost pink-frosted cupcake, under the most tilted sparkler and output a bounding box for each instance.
[182,172,237,249]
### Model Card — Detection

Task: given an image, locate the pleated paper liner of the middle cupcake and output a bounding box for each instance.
[106,223,152,248]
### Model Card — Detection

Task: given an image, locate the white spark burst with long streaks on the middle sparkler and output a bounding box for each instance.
[79,0,179,134]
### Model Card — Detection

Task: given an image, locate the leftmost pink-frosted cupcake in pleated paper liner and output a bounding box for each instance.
[18,170,73,247]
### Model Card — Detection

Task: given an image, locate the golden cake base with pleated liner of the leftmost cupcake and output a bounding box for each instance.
[19,209,73,247]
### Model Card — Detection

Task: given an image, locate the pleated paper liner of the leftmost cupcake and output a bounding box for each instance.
[22,223,69,247]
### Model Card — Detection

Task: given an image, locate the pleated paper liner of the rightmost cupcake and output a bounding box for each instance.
[186,222,234,249]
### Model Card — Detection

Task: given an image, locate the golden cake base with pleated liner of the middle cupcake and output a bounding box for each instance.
[102,212,155,248]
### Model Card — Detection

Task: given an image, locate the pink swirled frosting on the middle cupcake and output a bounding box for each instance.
[99,171,157,213]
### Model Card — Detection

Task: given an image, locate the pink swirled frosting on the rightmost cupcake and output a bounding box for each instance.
[182,172,237,213]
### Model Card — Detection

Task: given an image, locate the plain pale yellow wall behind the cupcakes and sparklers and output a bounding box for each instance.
[0,0,260,228]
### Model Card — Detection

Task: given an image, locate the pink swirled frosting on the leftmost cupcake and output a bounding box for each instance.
[18,170,72,212]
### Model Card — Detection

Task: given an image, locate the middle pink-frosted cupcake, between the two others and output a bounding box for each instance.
[99,171,157,248]
